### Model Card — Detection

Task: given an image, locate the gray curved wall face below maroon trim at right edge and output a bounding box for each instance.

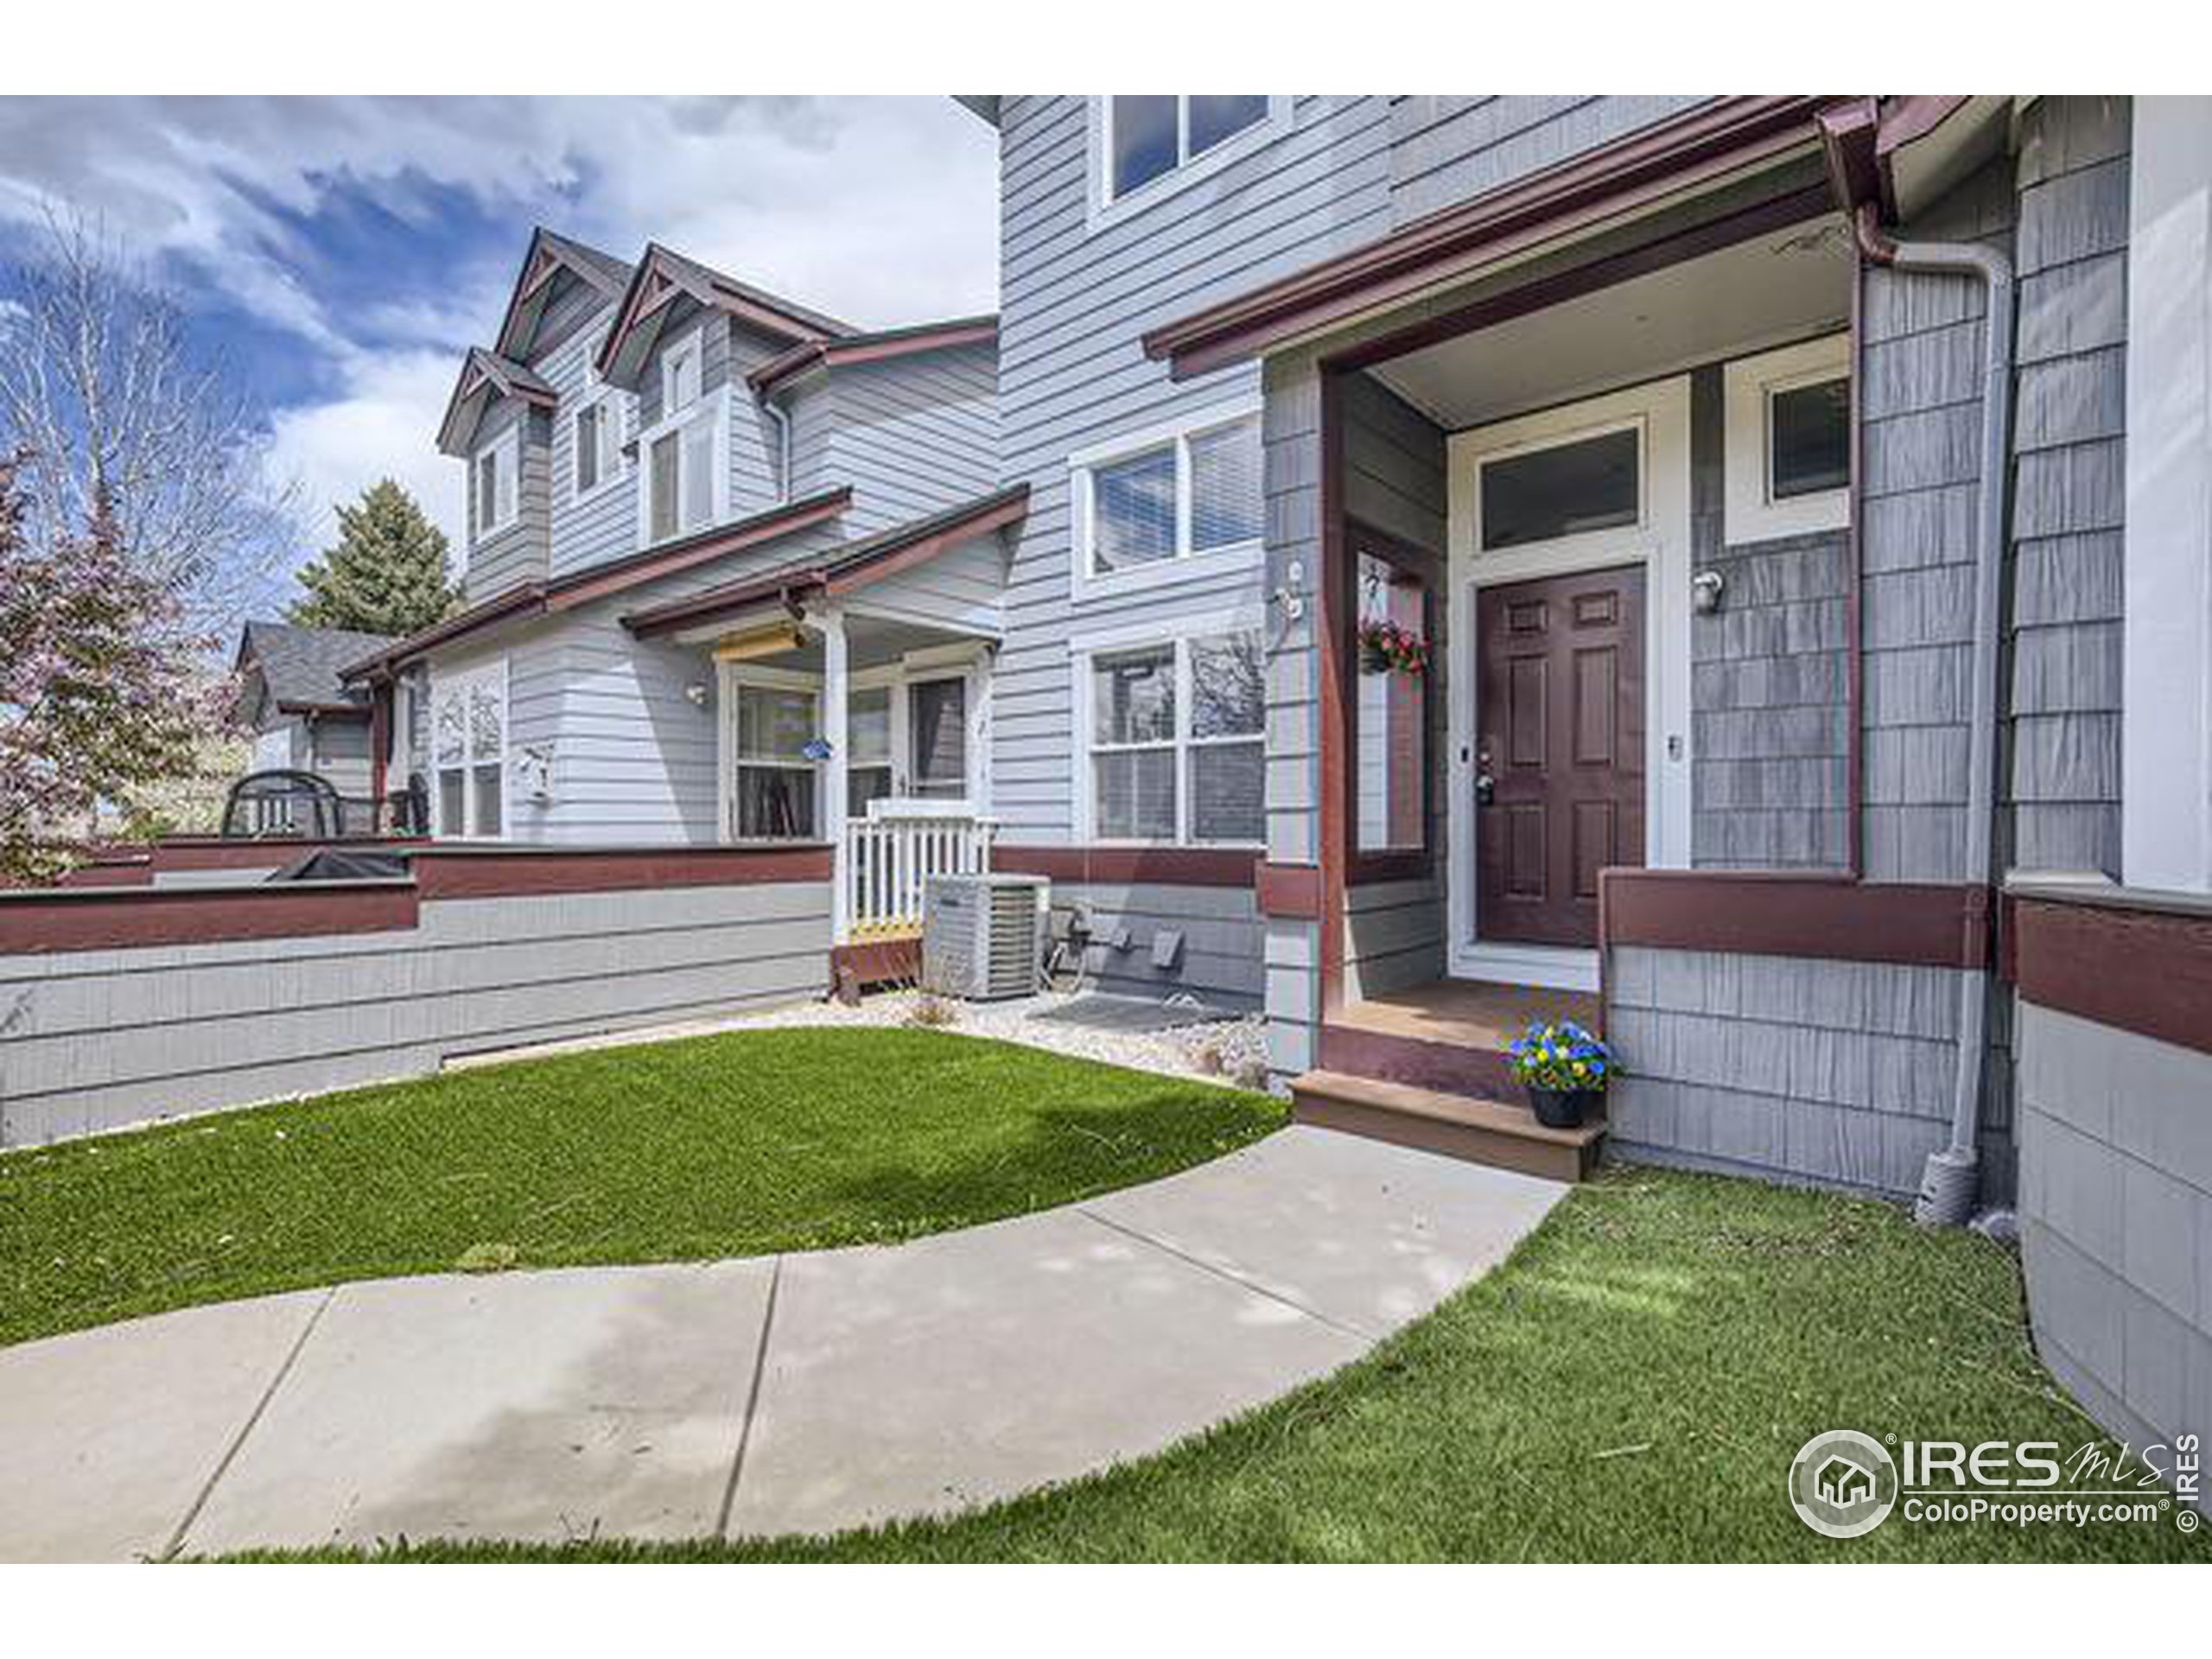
[2018,1002,2212,1446]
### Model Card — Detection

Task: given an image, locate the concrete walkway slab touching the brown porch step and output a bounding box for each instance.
[1082,1126,1568,1336]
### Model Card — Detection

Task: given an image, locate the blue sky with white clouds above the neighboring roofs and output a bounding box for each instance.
[0,98,998,557]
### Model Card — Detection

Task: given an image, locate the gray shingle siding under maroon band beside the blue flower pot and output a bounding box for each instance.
[1606,947,2011,1197]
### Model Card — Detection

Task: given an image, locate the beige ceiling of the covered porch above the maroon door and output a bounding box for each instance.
[1371,214,1853,431]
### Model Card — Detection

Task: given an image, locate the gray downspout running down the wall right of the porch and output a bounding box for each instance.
[1852,201,2013,1225]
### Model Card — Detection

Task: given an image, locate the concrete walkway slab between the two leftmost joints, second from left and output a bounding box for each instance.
[183,1259,774,1555]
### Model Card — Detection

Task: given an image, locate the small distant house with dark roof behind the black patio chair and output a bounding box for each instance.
[232,621,391,814]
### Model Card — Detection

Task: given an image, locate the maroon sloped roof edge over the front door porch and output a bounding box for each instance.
[1144,95,1838,380]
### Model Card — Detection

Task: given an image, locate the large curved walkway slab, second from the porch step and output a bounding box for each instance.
[730,1210,1365,1533]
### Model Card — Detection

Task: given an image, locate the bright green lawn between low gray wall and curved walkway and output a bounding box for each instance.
[0,1031,1283,1343]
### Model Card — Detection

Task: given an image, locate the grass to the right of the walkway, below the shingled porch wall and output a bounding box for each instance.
[251,1173,2205,1561]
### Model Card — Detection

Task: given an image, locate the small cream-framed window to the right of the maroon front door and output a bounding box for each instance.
[1723,334,1852,544]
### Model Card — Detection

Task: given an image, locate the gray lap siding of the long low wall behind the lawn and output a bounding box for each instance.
[0,882,830,1146]
